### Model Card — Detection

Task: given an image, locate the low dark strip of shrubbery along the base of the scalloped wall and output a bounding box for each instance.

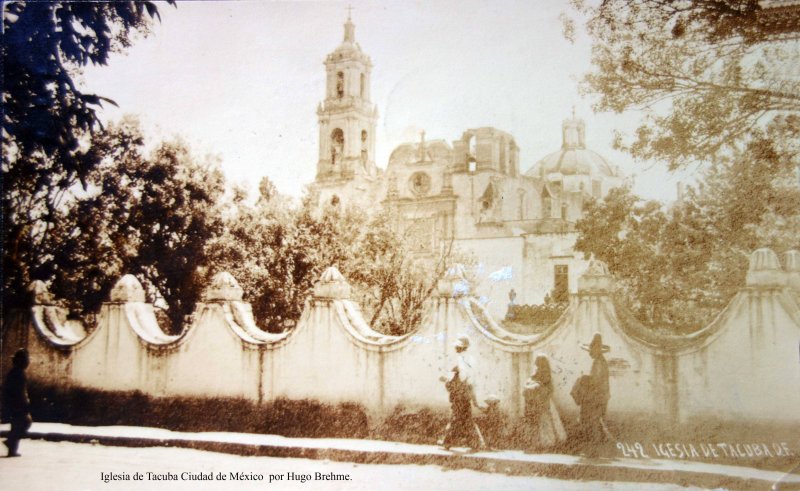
[23,384,800,470]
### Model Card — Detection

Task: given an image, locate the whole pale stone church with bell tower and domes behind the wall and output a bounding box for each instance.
[310,18,625,317]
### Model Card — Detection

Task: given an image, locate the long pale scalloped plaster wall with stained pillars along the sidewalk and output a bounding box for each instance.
[2,249,800,424]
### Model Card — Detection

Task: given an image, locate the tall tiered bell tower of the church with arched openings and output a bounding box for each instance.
[316,15,378,183]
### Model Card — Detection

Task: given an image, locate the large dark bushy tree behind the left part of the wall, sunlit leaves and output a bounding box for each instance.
[47,121,224,332]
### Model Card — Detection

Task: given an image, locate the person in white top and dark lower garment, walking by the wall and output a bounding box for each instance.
[441,336,486,450]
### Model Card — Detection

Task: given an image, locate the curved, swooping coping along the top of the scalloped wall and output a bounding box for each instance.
[25,256,800,360]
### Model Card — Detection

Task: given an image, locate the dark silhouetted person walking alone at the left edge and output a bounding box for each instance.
[3,348,33,457]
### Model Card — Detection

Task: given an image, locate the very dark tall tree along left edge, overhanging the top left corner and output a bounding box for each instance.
[2,2,174,308]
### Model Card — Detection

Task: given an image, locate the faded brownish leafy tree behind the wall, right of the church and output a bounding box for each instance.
[575,126,800,332]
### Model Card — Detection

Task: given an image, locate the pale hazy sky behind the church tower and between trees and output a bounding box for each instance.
[82,0,679,201]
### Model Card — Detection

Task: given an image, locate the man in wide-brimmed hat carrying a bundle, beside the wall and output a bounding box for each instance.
[572,334,611,448]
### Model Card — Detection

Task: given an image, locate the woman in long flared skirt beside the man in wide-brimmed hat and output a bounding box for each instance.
[521,355,567,450]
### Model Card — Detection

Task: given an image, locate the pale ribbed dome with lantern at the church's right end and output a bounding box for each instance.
[525,117,620,177]
